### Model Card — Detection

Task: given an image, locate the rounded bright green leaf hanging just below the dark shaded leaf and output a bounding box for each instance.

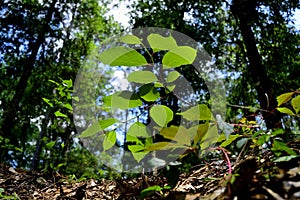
[150,105,173,127]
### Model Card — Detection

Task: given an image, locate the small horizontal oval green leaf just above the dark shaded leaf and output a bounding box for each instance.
[127,71,157,83]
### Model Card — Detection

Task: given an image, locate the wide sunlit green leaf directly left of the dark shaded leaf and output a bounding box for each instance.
[103,90,143,109]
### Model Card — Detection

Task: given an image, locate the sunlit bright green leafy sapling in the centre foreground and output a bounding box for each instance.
[79,34,225,166]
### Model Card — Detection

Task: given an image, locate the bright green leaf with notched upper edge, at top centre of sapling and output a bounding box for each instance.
[147,34,178,52]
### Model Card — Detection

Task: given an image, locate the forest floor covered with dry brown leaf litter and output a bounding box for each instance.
[0,148,300,200]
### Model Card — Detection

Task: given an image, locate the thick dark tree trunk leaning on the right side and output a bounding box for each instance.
[231,0,281,129]
